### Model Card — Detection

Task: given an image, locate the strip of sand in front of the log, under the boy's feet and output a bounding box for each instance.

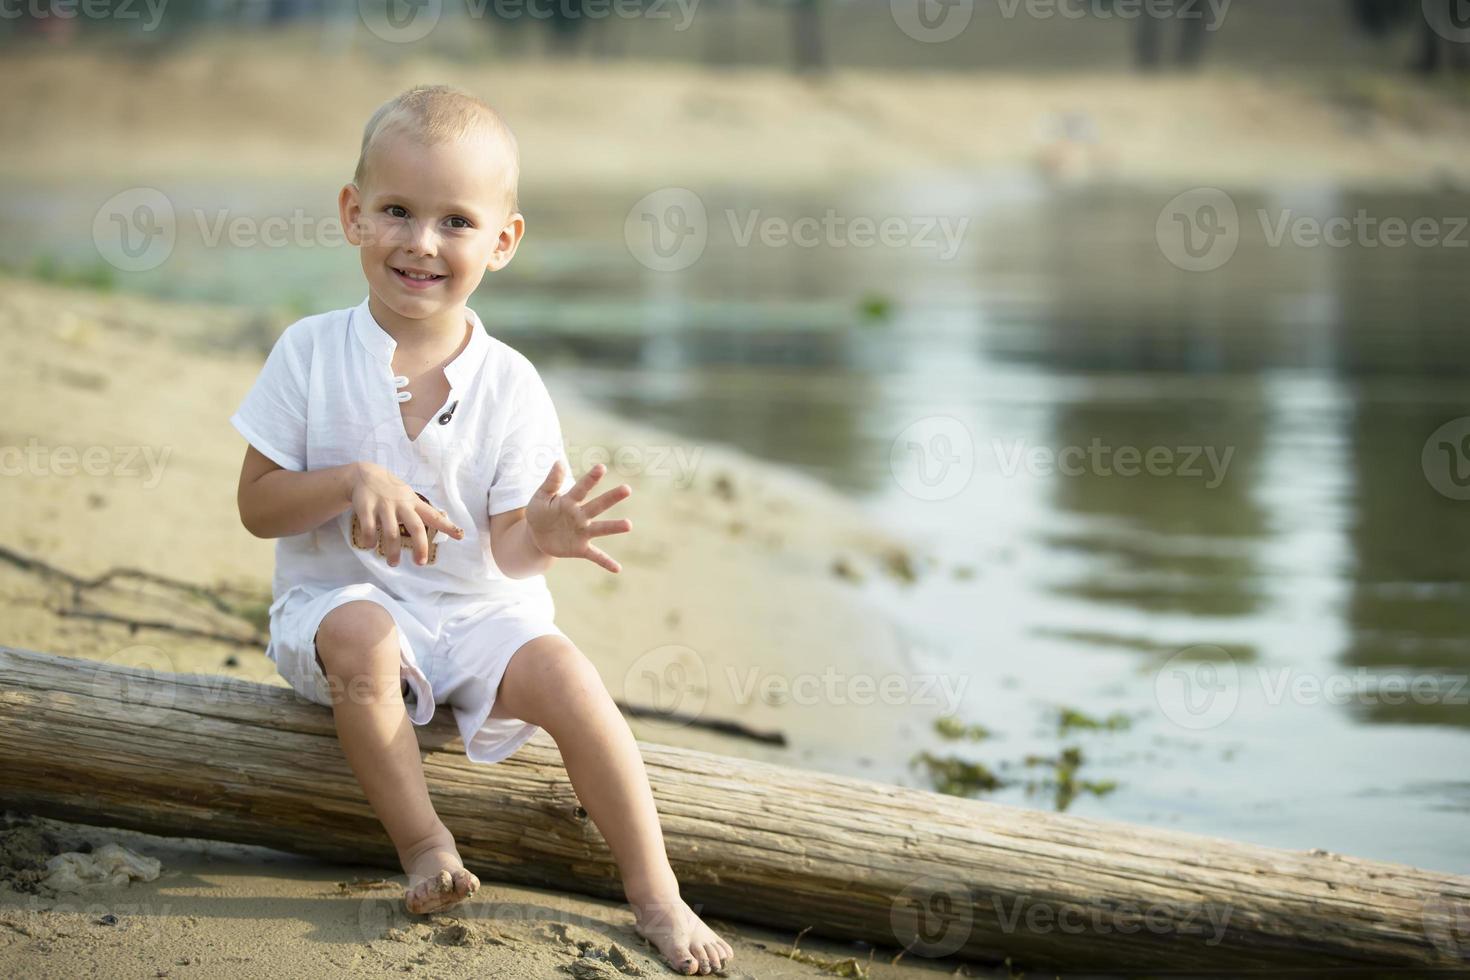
[0,818,987,980]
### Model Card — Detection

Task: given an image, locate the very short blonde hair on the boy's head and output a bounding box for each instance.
[353,85,520,213]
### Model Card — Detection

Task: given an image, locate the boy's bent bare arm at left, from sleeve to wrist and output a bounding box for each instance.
[235,445,360,538]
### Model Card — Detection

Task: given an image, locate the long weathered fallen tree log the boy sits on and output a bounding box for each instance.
[0,646,1470,976]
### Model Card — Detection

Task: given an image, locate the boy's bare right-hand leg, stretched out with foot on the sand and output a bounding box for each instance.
[491,635,735,974]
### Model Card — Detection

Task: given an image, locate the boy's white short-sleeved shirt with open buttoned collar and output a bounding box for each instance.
[229,300,576,601]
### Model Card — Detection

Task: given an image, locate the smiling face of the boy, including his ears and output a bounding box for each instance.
[338,132,525,320]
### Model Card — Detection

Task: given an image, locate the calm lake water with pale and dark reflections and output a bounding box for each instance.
[0,176,1470,871]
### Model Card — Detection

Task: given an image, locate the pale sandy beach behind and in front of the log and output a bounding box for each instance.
[0,279,987,977]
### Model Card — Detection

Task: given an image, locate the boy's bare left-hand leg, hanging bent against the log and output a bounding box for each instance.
[316,601,479,912]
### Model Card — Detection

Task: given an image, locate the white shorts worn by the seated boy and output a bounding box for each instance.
[266,582,566,763]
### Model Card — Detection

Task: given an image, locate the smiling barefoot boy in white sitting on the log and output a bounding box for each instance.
[231,85,734,974]
